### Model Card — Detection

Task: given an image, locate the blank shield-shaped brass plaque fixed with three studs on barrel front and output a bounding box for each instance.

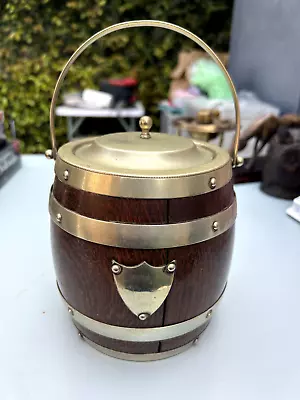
[112,261,175,321]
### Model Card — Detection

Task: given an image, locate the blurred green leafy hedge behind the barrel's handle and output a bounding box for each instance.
[0,0,232,153]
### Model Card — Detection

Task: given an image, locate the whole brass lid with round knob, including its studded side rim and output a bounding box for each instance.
[55,117,232,199]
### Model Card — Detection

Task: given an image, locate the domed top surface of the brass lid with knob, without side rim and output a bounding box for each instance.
[58,117,229,178]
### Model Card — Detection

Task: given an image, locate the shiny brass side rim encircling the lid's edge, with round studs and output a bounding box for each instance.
[55,144,232,199]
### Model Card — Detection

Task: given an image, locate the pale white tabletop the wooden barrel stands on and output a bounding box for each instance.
[0,156,300,400]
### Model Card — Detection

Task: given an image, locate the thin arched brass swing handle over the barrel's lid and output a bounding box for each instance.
[46,20,241,167]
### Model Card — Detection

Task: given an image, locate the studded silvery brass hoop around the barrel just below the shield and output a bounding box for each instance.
[58,286,226,342]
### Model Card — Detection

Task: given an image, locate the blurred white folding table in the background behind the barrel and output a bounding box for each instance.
[55,101,145,141]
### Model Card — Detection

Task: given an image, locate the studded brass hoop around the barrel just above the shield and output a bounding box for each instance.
[49,193,236,249]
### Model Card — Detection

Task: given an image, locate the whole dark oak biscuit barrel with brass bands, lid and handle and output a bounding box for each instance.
[47,21,244,361]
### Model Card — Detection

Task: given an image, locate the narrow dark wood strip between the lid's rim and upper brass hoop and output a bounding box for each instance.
[53,178,234,224]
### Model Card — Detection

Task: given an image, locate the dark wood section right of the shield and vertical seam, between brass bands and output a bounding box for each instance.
[164,227,234,325]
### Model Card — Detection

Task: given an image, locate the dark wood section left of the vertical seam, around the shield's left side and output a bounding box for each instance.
[51,222,167,328]
